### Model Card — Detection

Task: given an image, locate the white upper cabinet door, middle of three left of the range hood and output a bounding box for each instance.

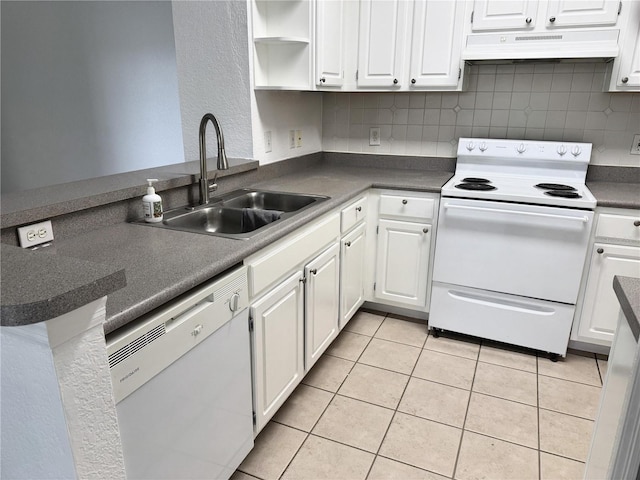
[358,0,410,88]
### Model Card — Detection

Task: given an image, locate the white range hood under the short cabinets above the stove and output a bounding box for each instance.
[462,29,620,63]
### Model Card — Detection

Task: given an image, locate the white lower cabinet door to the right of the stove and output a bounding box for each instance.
[578,243,640,345]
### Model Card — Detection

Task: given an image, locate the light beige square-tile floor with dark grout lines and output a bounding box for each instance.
[232,311,607,480]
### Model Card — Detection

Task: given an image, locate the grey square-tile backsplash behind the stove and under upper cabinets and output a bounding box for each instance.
[322,63,640,167]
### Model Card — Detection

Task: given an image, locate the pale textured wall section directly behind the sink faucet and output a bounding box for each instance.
[172,0,253,161]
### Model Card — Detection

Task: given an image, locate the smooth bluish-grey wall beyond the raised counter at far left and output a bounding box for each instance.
[1,1,184,192]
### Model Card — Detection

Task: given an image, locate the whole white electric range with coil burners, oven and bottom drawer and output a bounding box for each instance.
[429,138,596,357]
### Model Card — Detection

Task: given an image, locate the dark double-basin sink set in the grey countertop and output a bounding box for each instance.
[146,189,329,240]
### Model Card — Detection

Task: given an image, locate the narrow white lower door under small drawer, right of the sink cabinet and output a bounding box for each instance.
[340,223,366,329]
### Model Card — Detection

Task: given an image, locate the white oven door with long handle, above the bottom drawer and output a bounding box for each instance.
[433,198,593,304]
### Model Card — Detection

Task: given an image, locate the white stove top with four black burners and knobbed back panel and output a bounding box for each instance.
[442,138,596,210]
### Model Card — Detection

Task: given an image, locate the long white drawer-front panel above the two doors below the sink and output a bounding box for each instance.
[245,212,340,298]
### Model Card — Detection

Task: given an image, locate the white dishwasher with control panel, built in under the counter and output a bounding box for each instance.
[107,267,253,479]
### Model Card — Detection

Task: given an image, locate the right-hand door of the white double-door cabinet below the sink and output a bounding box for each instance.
[304,243,340,371]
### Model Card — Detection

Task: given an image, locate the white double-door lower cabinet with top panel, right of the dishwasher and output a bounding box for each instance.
[245,212,340,435]
